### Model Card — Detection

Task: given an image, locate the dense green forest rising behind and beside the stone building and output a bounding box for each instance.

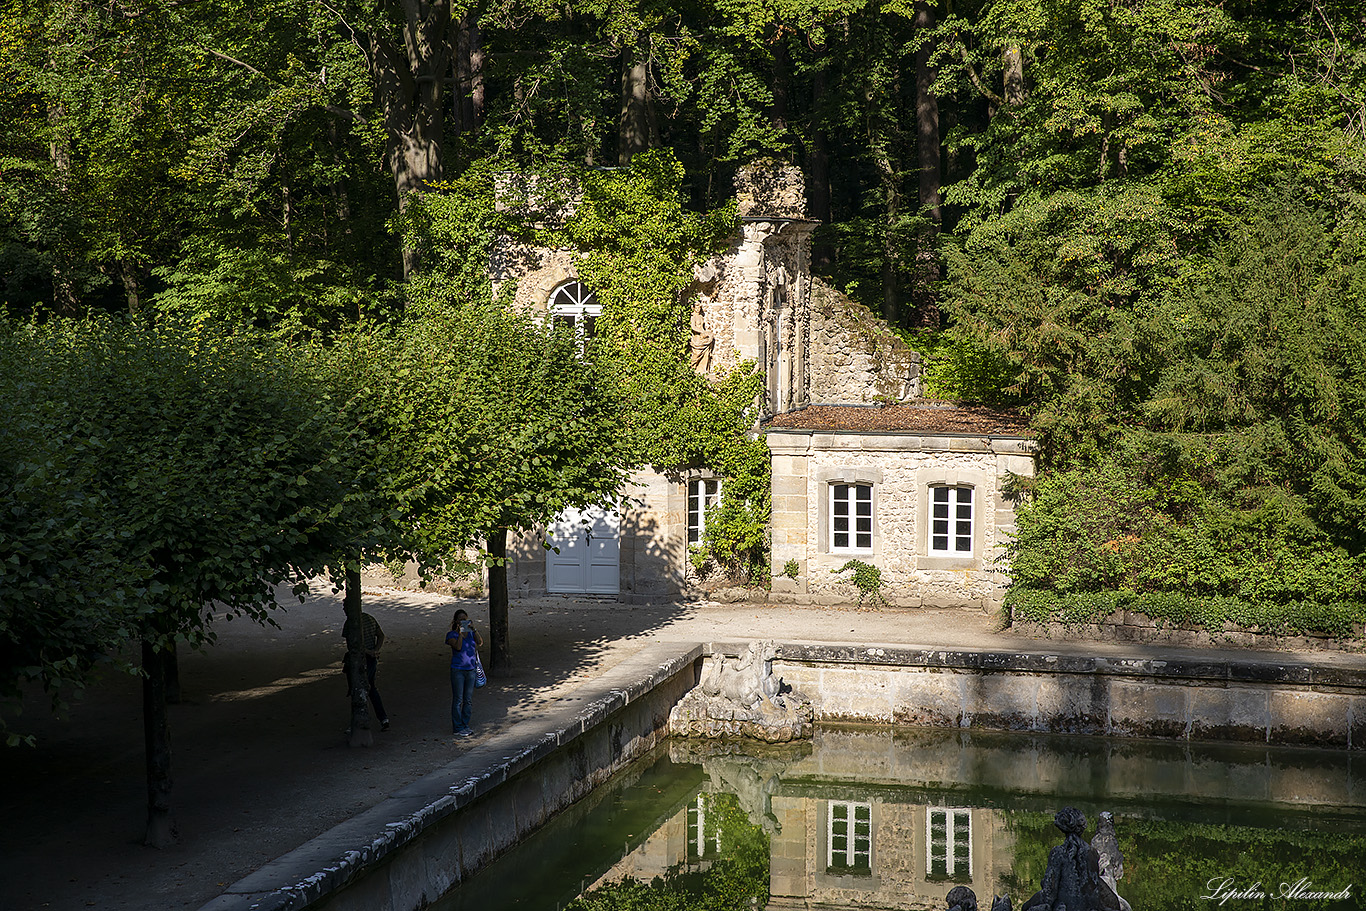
[0,0,1366,632]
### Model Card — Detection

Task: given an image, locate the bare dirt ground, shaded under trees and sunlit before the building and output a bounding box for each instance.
[0,586,993,911]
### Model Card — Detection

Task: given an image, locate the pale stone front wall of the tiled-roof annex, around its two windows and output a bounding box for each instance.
[768,430,1034,611]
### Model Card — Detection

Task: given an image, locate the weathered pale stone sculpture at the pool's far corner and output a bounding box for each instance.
[669,641,814,743]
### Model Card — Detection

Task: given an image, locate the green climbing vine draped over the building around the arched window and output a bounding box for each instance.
[402,150,770,582]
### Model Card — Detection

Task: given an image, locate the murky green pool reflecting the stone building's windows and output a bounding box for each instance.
[433,727,1366,911]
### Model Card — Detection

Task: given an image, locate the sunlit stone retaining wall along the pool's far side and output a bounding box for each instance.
[732,643,1366,750]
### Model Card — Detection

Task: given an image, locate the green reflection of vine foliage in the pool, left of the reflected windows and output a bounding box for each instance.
[567,792,769,911]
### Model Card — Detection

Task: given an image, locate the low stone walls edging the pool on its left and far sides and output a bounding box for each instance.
[199,641,1366,911]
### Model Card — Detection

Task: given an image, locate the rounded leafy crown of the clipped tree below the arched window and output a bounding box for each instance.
[311,305,624,557]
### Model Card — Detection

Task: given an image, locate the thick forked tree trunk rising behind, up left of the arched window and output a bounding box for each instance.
[366,0,456,277]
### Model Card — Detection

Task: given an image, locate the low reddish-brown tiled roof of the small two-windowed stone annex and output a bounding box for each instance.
[764,402,1033,437]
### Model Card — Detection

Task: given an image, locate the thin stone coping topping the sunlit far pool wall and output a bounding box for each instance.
[706,641,1366,690]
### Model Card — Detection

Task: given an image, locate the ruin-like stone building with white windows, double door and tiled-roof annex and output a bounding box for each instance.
[502,165,1034,609]
